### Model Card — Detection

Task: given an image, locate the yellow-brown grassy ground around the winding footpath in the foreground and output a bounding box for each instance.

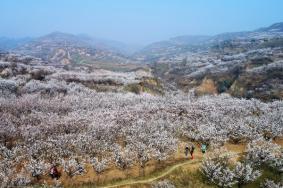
[32,139,283,188]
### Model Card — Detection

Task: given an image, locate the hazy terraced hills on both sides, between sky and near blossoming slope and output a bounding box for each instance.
[0,23,283,101]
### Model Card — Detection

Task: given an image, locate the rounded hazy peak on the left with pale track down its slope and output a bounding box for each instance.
[12,32,140,65]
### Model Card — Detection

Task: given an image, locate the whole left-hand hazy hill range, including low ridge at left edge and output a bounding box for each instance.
[0,32,144,65]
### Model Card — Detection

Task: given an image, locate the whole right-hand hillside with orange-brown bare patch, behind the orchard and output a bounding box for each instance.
[136,23,283,100]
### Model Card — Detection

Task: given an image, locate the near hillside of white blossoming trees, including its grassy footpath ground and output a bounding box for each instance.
[0,54,283,187]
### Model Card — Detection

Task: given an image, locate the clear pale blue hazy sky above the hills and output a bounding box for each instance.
[0,0,283,44]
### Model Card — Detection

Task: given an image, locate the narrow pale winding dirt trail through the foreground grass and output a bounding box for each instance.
[98,152,242,188]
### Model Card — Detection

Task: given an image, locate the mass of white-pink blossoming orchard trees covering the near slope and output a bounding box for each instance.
[0,55,283,187]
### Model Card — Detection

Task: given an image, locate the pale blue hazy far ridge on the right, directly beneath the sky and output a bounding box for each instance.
[134,23,283,62]
